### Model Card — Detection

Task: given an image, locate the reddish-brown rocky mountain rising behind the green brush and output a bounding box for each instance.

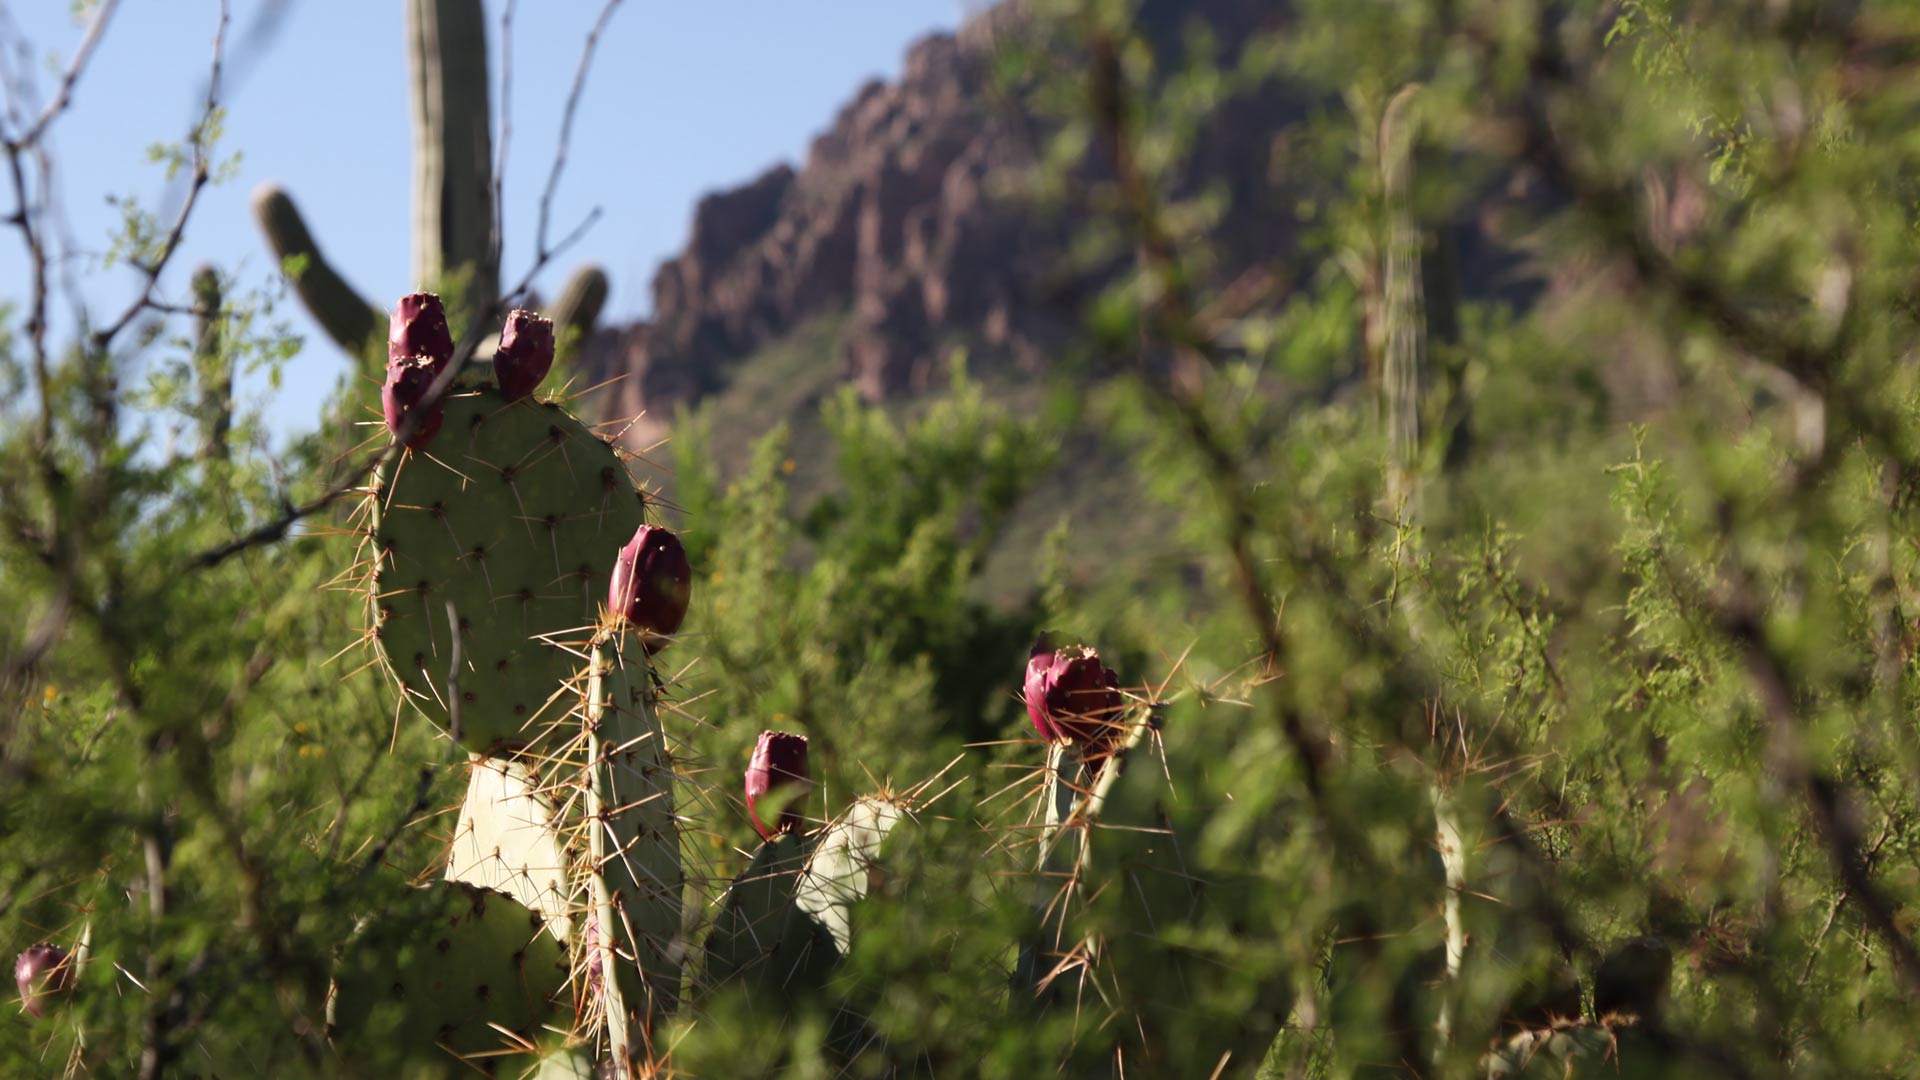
[584,0,1300,444]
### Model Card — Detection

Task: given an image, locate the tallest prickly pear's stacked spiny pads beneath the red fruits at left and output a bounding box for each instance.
[353,292,687,1067]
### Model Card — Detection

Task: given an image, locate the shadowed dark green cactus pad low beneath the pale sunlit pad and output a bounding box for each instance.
[328,884,572,1074]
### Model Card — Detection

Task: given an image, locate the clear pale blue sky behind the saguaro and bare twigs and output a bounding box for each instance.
[0,0,973,432]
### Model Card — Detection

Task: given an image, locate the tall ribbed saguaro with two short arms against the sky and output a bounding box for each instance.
[253,0,607,357]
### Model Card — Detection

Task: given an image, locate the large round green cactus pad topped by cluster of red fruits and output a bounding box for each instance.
[369,388,643,753]
